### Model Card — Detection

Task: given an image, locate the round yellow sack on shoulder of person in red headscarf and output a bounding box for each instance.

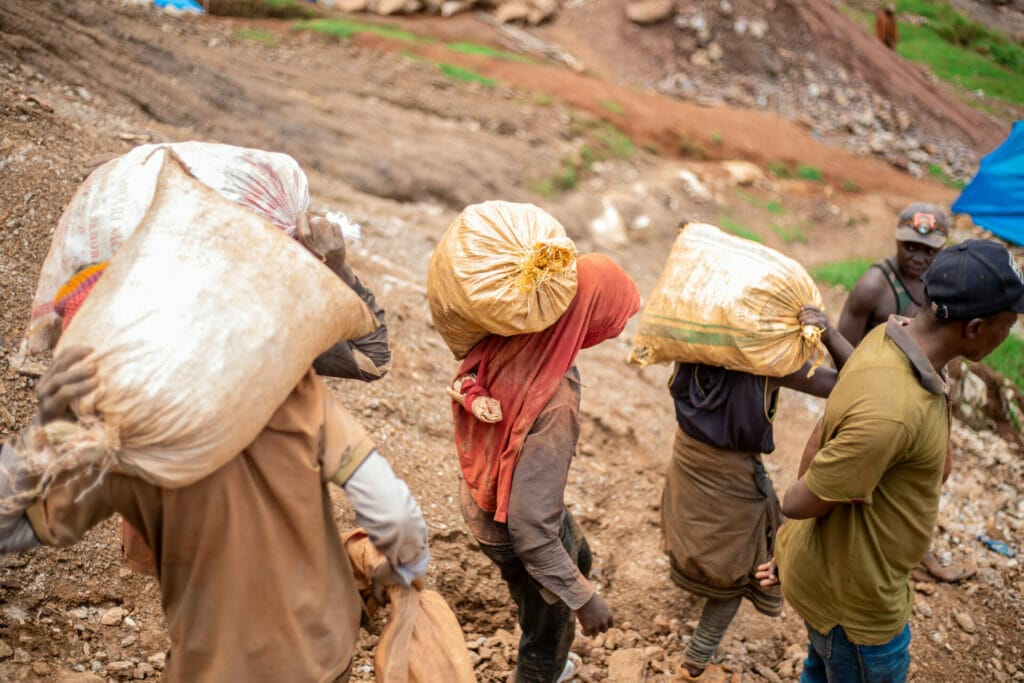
[427,202,577,358]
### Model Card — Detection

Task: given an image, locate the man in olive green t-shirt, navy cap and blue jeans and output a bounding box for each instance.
[775,240,1024,683]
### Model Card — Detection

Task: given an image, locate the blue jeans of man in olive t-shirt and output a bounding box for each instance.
[800,624,910,683]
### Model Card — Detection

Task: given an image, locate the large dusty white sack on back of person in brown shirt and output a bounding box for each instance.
[48,153,377,487]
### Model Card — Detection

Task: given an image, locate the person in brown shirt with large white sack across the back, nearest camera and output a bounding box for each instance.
[0,153,428,682]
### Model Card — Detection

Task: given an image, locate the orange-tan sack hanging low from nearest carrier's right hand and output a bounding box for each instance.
[342,528,476,683]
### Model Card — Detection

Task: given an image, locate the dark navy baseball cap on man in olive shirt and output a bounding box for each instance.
[924,240,1024,321]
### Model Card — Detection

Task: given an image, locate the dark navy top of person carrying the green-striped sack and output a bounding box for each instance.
[669,362,778,453]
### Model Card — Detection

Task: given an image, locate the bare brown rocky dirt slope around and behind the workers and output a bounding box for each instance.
[0,0,1024,682]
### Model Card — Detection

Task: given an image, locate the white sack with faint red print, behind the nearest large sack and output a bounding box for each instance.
[19,141,309,358]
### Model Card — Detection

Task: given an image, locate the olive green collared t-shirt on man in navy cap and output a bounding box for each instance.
[775,316,949,645]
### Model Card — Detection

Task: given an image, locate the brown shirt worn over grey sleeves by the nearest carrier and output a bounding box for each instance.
[28,372,373,683]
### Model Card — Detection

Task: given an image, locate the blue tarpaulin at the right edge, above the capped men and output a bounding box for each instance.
[952,121,1024,245]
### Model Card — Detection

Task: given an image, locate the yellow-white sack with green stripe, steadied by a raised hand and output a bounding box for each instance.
[630,223,825,377]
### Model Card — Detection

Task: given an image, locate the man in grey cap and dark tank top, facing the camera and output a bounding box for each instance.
[839,202,950,346]
